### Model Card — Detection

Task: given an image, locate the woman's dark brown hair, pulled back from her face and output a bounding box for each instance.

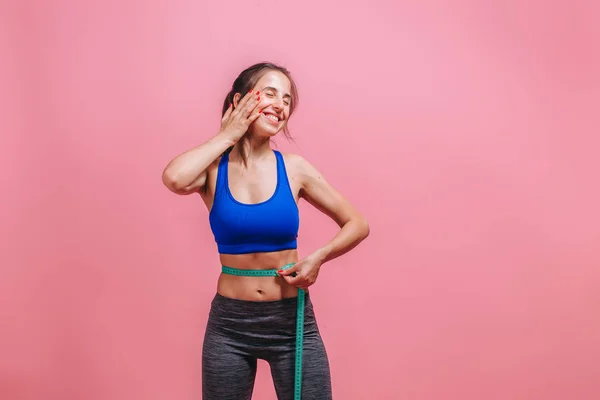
[221,62,298,156]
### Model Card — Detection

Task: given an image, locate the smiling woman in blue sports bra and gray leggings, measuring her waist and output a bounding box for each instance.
[163,63,369,400]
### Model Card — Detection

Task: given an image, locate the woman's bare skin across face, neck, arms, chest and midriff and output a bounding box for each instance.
[163,71,369,301]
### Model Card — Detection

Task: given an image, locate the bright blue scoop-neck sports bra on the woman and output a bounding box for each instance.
[209,150,300,254]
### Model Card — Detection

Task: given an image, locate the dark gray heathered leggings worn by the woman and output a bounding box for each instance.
[202,293,331,400]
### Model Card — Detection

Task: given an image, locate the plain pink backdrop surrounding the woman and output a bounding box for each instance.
[0,0,600,400]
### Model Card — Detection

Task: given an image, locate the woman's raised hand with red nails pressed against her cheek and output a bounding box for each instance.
[219,92,262,143]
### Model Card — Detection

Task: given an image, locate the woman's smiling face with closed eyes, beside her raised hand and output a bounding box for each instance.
[250,71,292,136]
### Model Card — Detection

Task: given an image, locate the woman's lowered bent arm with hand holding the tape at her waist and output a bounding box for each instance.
[280,155,369,289]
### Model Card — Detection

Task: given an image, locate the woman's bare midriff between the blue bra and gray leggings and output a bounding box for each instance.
[217,249,298,301]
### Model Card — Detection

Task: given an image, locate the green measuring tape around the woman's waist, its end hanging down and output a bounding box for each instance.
[221,263,305,400]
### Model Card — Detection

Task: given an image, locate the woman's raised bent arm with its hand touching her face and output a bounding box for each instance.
[162,92,260,194]
